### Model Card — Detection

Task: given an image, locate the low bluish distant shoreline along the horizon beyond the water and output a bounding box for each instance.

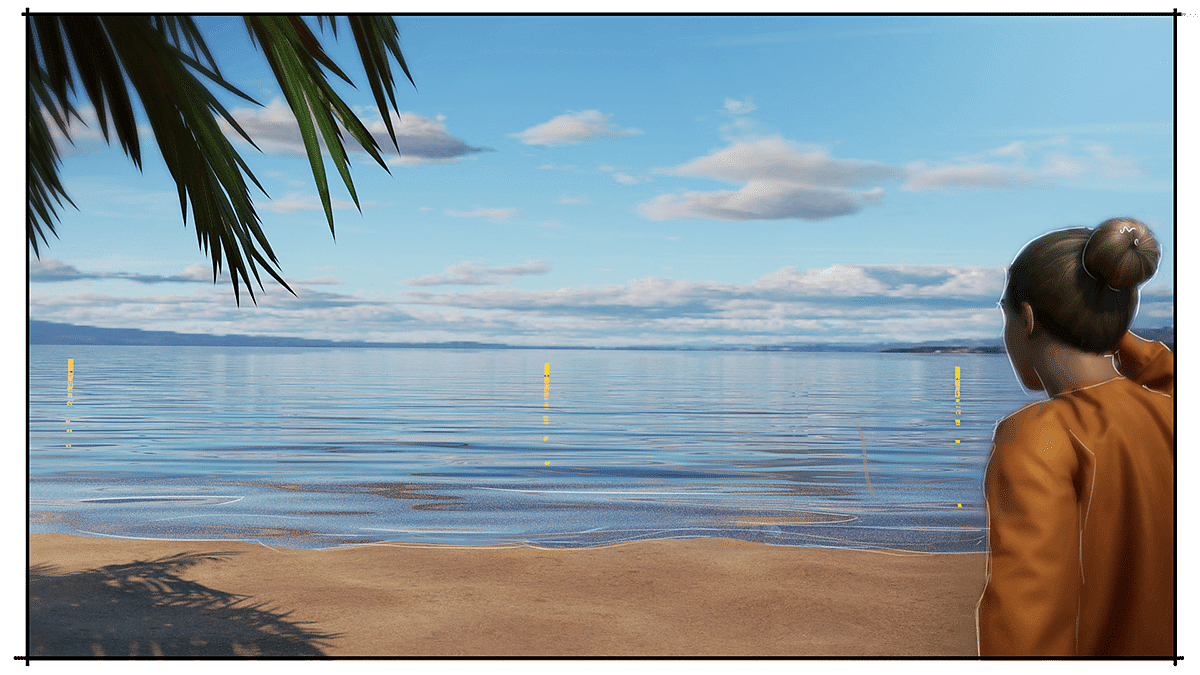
[29,319,1175,354]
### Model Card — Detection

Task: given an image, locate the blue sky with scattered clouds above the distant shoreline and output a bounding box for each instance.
[29,16,1175,347]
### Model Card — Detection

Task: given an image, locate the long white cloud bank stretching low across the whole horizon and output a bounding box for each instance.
[29,259,1174,346]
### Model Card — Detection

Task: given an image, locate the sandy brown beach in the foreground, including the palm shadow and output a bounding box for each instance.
[29,534,984,658]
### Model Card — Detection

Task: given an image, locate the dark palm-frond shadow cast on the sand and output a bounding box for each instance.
[29,552,337,657]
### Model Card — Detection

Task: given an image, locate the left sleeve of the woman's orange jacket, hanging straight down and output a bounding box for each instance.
[976,404,1080,656]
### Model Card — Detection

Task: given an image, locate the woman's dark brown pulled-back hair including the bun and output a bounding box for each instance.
[1001,217,1160,354]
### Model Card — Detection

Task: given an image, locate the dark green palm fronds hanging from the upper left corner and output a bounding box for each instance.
[25,14,415,305]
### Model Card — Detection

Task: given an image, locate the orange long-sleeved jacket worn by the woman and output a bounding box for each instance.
[976,333,1175,656]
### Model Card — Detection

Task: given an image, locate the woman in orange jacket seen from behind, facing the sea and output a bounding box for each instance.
[976,219,1175,656]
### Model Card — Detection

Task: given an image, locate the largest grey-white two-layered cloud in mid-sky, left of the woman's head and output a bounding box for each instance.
[638,137,901,220]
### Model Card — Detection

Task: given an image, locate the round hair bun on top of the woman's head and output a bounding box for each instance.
[1084,217,1162,291]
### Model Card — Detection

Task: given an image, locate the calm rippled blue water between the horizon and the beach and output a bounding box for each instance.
[29,345,1042,552]
